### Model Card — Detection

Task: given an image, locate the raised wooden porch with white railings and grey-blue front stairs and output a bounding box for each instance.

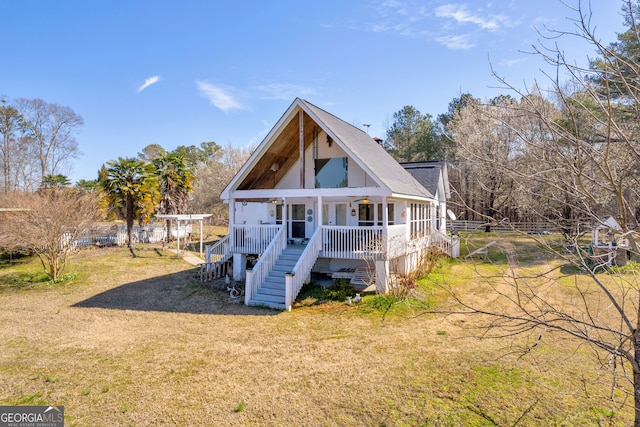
[201,224,457,309]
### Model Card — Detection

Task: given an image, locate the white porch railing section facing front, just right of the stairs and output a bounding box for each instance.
[322,225,384,259]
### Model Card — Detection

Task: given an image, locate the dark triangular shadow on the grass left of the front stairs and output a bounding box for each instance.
[72,270,280,316]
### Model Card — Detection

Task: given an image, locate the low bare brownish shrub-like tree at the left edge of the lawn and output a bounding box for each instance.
[0,187,101,280]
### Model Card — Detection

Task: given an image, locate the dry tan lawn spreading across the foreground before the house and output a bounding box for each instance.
[0,242,632,426]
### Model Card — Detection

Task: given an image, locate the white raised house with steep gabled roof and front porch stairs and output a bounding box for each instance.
[207,98,456,309]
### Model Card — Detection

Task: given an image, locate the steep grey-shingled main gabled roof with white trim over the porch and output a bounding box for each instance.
[222,98,434,198]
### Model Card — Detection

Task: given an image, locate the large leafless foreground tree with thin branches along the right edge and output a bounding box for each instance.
[444,1,640,426]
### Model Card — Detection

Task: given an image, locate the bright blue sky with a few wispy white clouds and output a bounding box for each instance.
[0,0,624,181]
